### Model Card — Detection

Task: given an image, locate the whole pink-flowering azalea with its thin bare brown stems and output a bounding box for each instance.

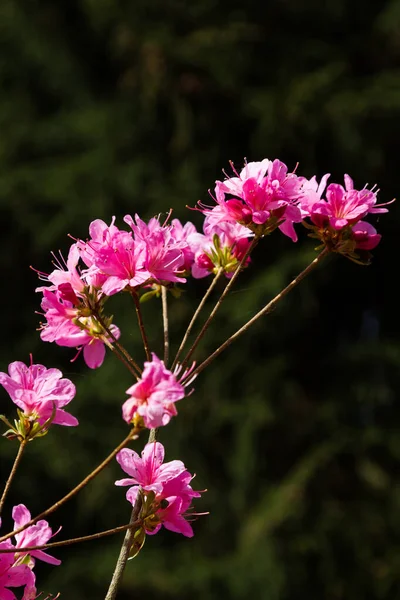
[0,159,388,600]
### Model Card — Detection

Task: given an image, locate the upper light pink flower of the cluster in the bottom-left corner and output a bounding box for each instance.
[12,504,61,565]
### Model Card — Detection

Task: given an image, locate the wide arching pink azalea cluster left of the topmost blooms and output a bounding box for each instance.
[37,215,252,369]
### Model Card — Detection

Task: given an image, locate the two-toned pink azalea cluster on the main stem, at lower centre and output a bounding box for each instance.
[115,442,201,537]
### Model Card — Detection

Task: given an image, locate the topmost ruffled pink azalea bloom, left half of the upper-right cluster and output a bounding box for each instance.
[200,159,301,241]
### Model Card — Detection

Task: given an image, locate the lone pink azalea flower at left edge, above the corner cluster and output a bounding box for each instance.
[0,361,78,425]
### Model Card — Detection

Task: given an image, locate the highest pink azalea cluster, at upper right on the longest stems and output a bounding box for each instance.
[198,159,387,259]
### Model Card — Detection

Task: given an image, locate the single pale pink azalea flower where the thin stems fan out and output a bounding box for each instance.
[122,353,195,429]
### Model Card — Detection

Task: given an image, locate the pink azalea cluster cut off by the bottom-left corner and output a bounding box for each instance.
[0,504,61,600]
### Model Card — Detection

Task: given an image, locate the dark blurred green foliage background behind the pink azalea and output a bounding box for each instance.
[0,0,400,600]
